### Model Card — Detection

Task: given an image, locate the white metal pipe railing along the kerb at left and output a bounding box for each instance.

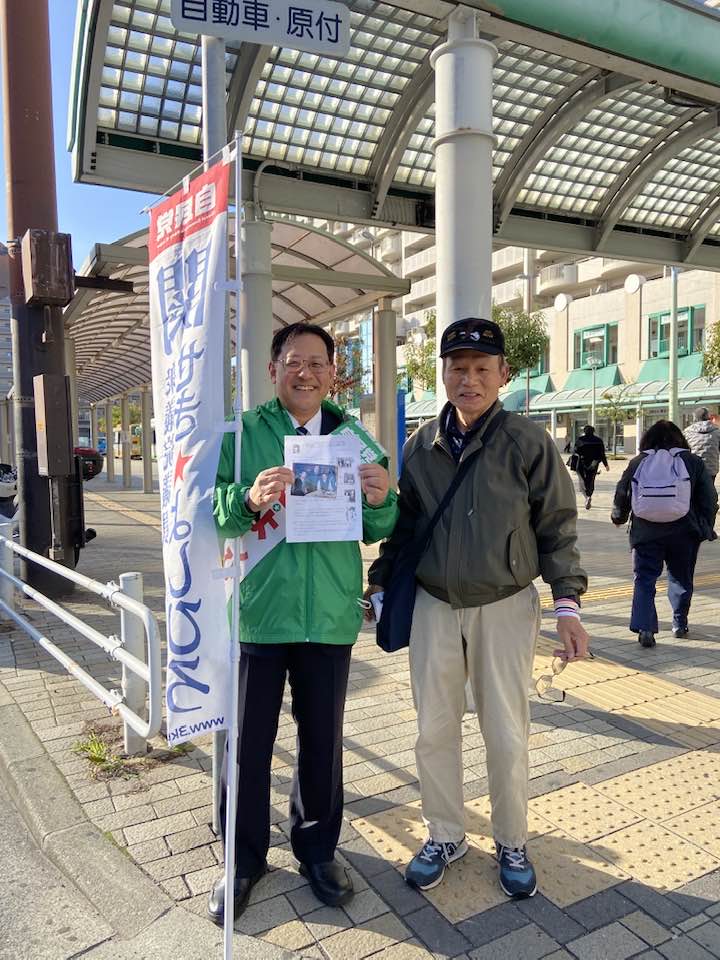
[0,534,162,742]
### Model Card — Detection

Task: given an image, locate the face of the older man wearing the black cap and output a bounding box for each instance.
[443,350,508,427]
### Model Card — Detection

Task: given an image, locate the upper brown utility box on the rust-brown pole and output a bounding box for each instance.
[22,230,75,307]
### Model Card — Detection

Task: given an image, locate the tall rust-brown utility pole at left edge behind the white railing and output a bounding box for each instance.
[0,0,75,595]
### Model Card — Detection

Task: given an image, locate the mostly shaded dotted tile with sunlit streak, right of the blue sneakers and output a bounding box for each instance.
[528,830,628,907]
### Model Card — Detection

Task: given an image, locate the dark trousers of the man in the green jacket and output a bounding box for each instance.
[220,643,352,877]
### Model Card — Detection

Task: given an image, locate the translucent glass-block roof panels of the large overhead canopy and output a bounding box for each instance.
[71,0,720,267]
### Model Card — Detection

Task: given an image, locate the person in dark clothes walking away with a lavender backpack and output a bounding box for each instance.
[610,420,718,647]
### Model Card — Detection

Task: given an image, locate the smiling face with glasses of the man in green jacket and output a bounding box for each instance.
[270,333,335,425]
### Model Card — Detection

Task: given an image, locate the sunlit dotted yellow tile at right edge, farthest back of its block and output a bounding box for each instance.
[595,750,720,821]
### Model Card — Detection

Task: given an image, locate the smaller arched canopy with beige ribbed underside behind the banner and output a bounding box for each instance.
[64,218,410,403]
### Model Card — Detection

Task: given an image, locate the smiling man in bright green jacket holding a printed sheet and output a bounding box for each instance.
[208,323,397,925]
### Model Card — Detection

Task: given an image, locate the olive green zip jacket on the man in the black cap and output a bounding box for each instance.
[369,403,587,608]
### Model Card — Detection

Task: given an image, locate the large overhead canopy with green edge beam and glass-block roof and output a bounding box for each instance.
[70,0,720,269]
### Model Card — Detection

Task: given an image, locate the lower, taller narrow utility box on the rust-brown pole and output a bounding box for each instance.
[33,373,75,477]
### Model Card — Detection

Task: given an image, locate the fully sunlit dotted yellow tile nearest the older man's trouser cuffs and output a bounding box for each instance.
[530,783,641,843]
